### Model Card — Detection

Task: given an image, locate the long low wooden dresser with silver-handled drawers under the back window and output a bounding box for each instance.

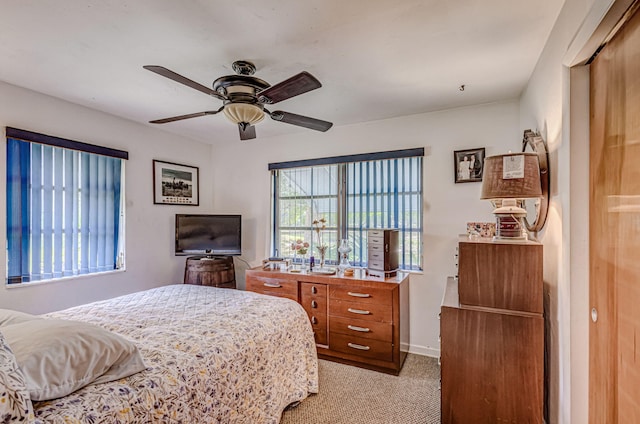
[246,268,409,375]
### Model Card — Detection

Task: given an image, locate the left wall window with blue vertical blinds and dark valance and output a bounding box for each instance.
[7,128,128,284]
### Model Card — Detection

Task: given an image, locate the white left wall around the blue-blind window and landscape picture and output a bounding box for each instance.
[0,83,212,313]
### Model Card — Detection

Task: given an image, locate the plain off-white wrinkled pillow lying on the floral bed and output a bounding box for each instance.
[2,319,145,401]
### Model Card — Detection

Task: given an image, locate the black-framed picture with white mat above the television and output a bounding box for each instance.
[153,159,200,206]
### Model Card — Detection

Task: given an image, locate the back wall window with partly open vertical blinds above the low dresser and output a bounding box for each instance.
[269,149,424,270]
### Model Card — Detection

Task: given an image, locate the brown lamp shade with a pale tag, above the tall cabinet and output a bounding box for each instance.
[480,153,542,200]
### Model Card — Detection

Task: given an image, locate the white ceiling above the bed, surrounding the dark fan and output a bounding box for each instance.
[0,0,563,144]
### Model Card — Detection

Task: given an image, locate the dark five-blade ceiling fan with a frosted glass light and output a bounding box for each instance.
[143,60,333,140]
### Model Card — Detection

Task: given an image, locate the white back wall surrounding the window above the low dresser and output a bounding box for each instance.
[213,101,523,356]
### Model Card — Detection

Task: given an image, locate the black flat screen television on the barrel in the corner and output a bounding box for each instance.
[175,214,242,256]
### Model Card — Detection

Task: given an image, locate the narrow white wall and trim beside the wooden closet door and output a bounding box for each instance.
[520,0,600,423]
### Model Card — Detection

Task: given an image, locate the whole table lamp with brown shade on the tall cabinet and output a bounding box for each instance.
[480,153,542,241]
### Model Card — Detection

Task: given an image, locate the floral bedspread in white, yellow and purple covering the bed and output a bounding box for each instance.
[34,285,318,424]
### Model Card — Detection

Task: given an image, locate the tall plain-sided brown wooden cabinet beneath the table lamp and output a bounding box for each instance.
[440,237,544,424]
